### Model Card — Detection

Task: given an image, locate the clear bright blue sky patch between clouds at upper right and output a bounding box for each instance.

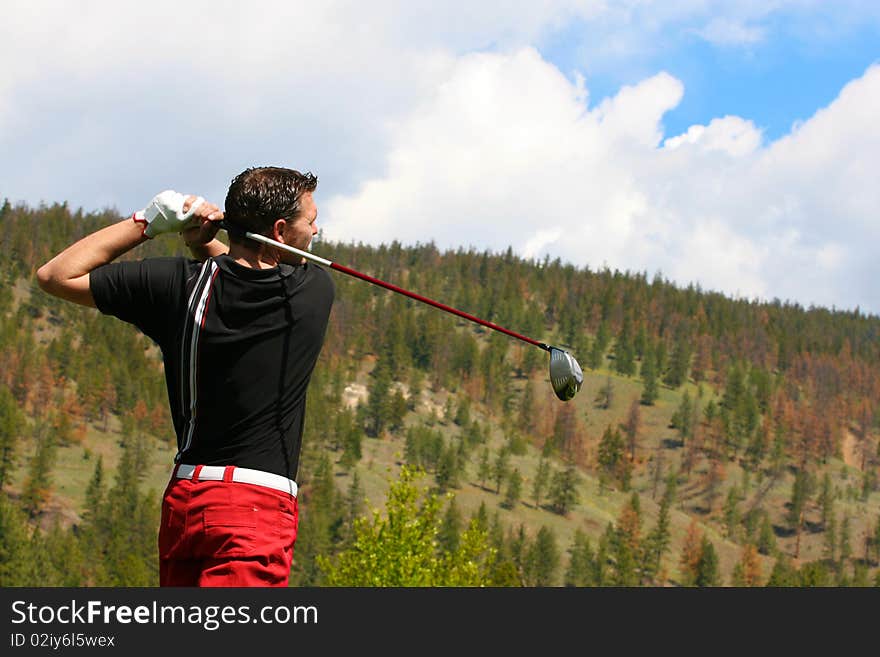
[539,3,880,140]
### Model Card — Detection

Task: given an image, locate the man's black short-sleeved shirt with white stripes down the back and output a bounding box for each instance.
[90,255,334,479]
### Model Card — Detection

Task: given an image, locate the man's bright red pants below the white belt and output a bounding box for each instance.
[159,468,298,586]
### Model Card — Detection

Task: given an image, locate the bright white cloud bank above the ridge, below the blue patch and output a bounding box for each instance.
[324,49,880,310]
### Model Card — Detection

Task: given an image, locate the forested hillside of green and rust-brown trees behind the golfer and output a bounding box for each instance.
[0,202,880,586]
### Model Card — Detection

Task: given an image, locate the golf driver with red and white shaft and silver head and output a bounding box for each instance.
[219,221,584,401]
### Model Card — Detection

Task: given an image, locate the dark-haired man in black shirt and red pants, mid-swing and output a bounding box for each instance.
[37,167,334,586]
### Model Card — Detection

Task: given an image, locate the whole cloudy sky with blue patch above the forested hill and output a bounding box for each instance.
[0,0,880,314]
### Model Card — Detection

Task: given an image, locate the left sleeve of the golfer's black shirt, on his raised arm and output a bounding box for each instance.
[89,258,197,345]
